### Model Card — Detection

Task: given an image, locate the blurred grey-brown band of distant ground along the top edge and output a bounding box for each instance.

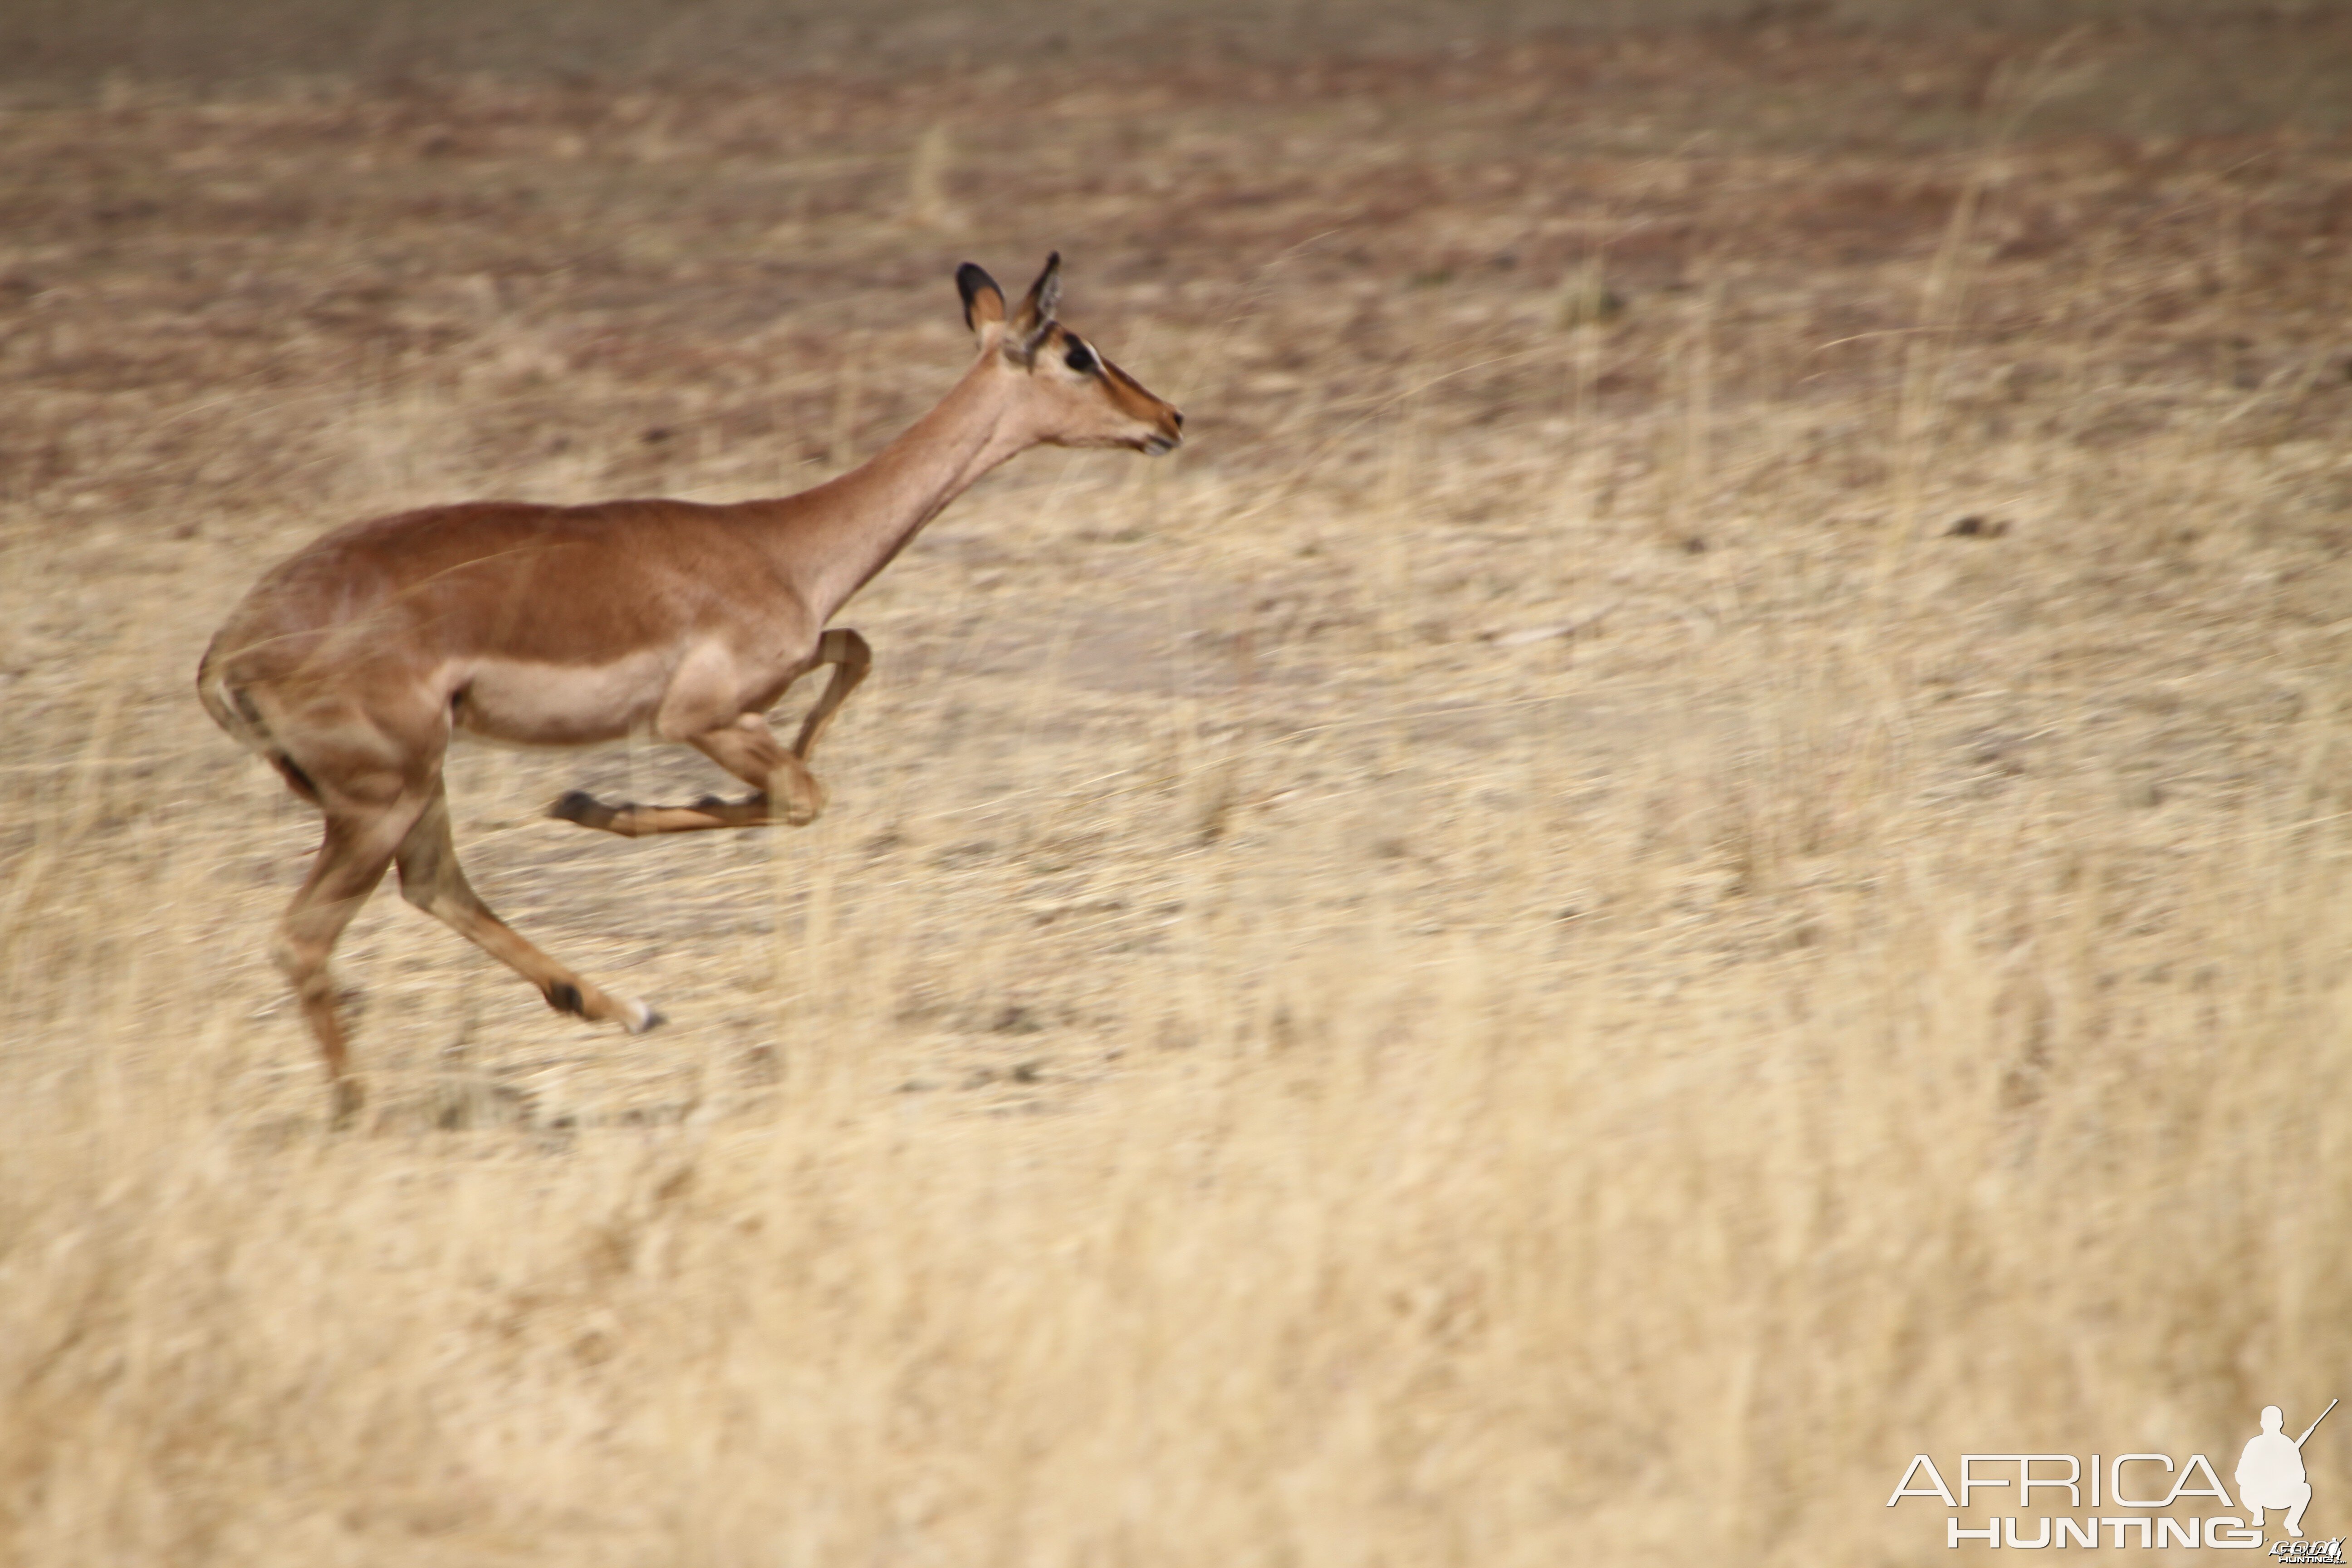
[0,0,2345,134]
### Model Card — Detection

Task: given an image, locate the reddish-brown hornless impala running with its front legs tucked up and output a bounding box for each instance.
[197,254,1183,1122]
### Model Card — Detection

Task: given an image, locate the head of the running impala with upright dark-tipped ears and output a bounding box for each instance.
[955,251,1183,456]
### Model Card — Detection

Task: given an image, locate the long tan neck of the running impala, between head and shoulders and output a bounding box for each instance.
[760,353,1035,625]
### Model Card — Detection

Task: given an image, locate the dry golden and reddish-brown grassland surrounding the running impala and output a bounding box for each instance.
[0,5,2352,1566]
